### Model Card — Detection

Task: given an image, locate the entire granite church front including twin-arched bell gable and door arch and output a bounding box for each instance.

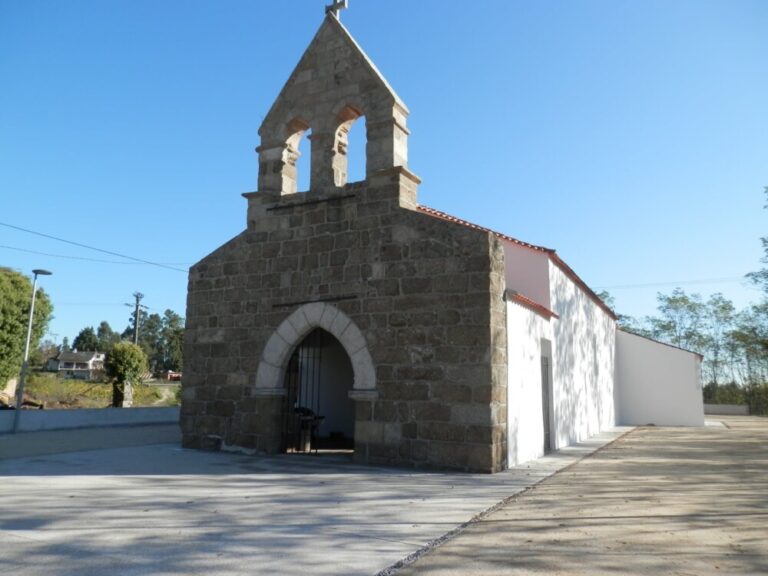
[181,15,507,472]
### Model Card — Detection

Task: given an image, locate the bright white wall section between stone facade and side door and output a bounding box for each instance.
[507,301,556,466]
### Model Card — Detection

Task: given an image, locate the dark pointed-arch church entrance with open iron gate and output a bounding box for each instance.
[283,328,355,453]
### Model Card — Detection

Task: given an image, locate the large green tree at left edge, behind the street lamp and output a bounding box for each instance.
[0,268,53,385]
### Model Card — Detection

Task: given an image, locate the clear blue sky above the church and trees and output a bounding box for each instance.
[0,0,768,342]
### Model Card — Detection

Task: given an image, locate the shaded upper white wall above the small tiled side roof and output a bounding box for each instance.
[503,240,550,308]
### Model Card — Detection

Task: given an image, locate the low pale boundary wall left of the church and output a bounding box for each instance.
[0,406,179,434]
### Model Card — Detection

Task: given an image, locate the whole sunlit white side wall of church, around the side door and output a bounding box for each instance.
[505,248,616,466]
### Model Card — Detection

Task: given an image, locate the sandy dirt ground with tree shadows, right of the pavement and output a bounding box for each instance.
[398,417,768,575]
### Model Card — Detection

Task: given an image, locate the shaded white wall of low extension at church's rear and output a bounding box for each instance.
[616,330,704,426]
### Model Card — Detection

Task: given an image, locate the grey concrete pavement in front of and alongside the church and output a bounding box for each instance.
[0,429,626,576]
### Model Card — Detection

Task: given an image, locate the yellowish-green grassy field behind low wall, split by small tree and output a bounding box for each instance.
[24,372,180,409]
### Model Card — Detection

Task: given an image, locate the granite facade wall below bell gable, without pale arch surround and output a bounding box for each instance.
[181,170,507,472]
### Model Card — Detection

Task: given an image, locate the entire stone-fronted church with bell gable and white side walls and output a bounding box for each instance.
[181,12,703,472]
